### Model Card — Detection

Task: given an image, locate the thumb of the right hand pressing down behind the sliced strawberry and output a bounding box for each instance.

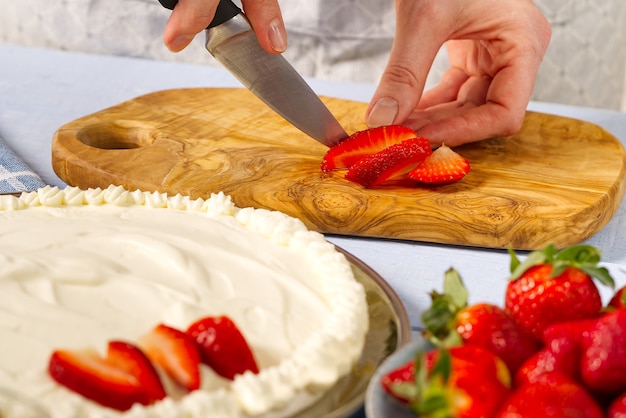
[365,0,445,127]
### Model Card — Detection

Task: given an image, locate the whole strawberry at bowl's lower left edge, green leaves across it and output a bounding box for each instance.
[381,345,510,418]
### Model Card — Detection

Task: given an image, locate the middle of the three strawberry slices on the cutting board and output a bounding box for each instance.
[345,138,432,188]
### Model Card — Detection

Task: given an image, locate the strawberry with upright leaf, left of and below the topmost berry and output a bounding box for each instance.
[422,269,540,374]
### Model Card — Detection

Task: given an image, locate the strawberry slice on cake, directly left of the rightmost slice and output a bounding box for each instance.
[139,324,200,392]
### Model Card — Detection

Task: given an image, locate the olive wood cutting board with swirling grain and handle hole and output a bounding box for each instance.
[52,88,626,250]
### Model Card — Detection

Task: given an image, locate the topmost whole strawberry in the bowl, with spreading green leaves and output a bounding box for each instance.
[505,245,614,339]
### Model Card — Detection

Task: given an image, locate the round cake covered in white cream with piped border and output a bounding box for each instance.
[0,186,368,418]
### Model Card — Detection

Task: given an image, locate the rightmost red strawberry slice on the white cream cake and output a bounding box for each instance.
[187,316,259,380]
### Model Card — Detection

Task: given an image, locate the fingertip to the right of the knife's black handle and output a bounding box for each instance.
[243,0,287,53]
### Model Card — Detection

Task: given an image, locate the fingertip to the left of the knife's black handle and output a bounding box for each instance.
[163,0,218,52]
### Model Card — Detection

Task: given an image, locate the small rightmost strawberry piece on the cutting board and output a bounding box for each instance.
[408,144,470,184]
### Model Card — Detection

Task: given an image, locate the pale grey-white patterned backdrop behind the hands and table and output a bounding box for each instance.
[0,0,626,109]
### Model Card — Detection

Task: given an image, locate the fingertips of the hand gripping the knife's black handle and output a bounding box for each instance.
[163,0,287,53]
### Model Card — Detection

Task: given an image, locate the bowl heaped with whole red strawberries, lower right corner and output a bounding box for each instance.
[365,245,626,418]
